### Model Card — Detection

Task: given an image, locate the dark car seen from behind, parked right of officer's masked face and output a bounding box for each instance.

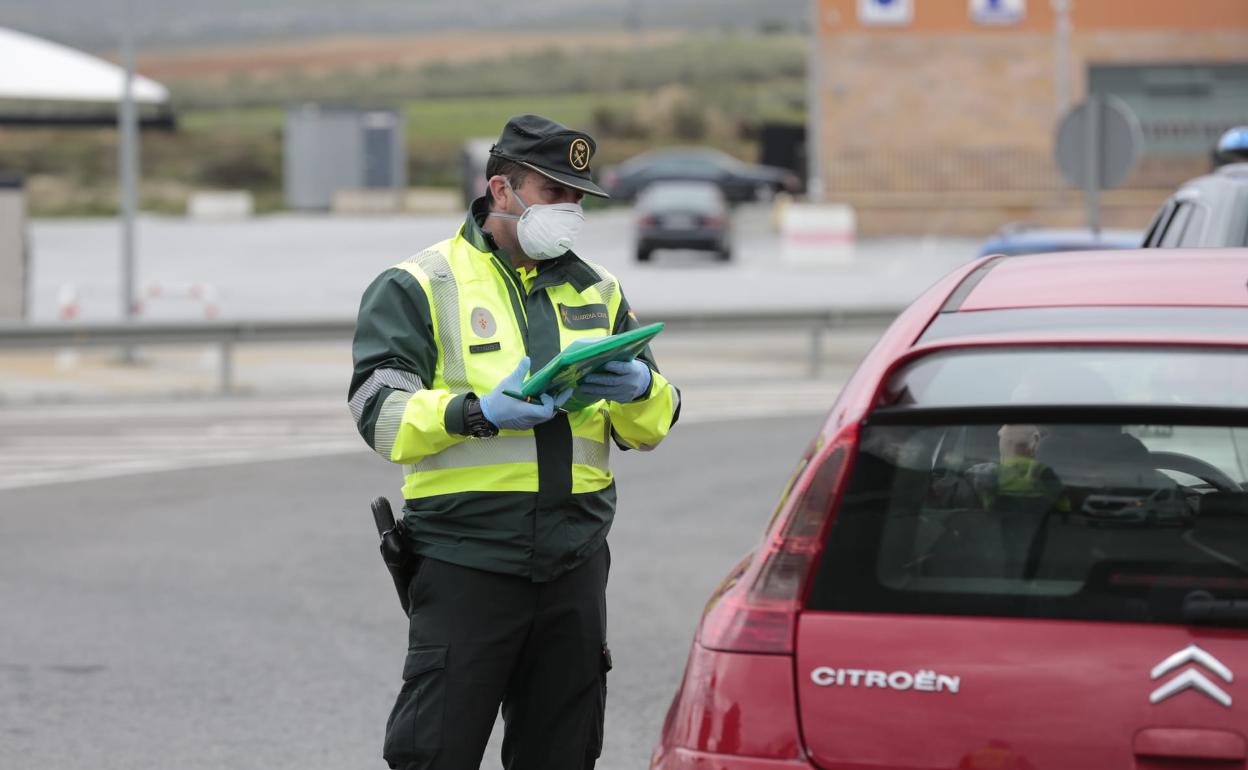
[634,181,733,262]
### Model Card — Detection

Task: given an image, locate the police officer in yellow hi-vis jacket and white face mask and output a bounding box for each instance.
[349,115,680,770]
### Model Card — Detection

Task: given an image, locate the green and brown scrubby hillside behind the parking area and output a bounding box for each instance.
[0,34,805,216]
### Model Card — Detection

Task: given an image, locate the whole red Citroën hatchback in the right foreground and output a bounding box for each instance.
[651,250,1248,770]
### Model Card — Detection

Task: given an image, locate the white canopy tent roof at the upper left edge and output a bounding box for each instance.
[0,27,168,104]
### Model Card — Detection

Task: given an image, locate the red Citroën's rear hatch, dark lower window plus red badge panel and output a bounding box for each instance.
[795,381,1248,770]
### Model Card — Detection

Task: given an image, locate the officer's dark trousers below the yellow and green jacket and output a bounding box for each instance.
[383,545,610,770]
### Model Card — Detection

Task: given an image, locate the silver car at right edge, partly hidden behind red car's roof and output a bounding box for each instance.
[1144,162,1248,248]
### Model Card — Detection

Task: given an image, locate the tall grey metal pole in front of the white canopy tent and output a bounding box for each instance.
[117,0,139,329]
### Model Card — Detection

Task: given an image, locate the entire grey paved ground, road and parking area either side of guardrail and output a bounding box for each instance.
[0,210,943,770]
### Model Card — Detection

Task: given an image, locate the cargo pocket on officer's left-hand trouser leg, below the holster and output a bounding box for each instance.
[382,644,447,768]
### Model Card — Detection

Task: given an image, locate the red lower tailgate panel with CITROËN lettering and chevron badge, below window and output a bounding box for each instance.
[796,612,1248,770]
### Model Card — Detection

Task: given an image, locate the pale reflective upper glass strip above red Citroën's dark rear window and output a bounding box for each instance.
[884,346,1248,407]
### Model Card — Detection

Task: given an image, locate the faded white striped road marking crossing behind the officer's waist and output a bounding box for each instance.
[0,381,837,490]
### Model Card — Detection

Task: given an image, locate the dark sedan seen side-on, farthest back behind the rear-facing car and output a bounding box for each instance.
[602,147,801,203]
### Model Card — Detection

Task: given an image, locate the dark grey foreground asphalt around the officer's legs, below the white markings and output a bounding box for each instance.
[0,409,820,770]
